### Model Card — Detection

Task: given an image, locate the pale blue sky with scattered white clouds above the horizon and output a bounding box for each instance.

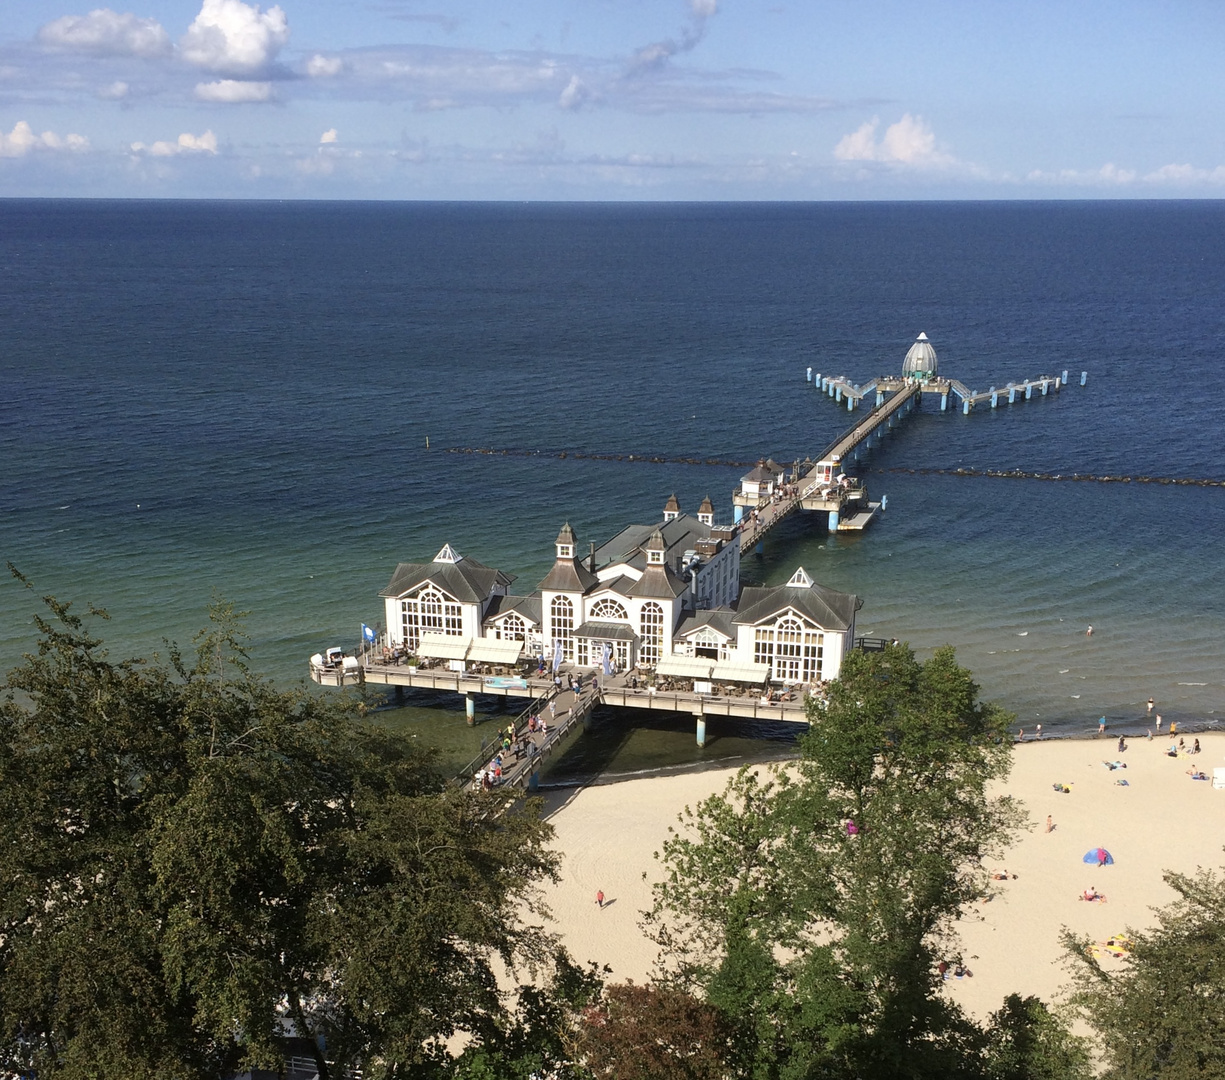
[0,0,1225,201]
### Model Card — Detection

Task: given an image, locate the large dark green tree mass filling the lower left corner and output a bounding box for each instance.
[0,580,556,1078]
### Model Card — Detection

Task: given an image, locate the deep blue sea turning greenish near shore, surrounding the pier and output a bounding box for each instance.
[0,200,1225,782]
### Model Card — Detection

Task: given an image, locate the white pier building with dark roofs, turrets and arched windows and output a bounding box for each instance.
[382,513,860,683]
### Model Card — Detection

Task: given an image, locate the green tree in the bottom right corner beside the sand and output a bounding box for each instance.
[1065,869,1225,1080]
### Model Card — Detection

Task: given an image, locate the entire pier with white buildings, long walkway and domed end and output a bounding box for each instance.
[310,334,1088,749]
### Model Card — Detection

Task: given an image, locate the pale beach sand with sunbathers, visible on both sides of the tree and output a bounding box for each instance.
[546,733,1225,1018]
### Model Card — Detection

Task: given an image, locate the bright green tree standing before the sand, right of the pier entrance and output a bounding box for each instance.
[648,647,1022,1078]
